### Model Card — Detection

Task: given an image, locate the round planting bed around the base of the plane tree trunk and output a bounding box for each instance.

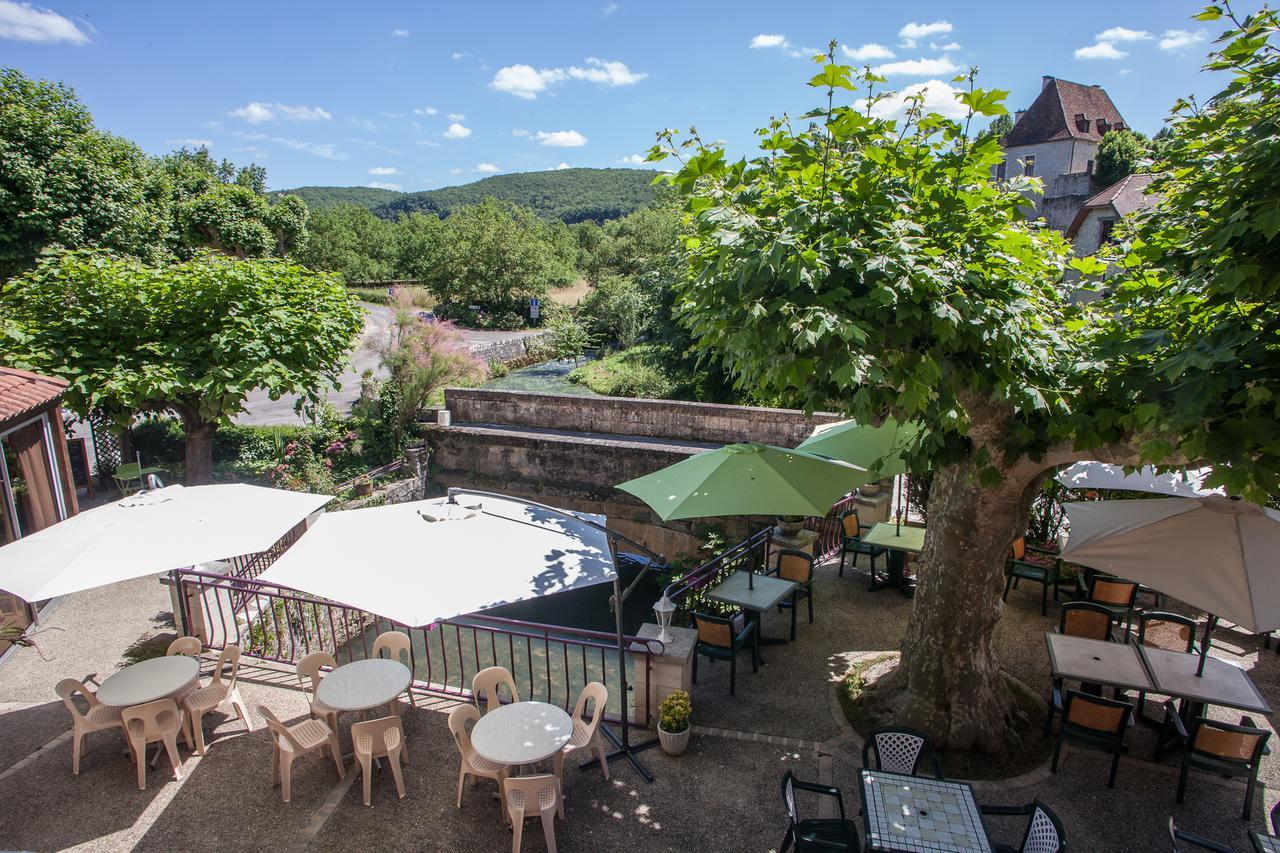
[837,654,1053,779]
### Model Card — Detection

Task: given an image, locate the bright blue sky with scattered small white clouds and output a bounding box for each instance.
[0,0,1239,191]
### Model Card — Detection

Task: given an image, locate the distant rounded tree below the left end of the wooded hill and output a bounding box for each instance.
[296,202,398,284]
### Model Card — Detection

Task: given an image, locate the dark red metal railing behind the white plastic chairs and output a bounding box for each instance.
[172,569,664,727]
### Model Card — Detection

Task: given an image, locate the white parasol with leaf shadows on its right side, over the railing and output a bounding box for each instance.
[259,494,616,628]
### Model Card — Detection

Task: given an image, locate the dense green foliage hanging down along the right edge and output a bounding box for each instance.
[1098,3,1280,502]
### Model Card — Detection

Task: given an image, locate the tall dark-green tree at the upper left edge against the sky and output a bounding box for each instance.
[0,68,170,279]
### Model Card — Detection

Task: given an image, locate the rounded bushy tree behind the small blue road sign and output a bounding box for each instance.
[420,199,573,313]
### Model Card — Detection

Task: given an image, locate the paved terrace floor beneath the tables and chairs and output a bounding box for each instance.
[0,550,1280,853]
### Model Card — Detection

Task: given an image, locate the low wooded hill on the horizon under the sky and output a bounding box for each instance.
[273,169,658,223]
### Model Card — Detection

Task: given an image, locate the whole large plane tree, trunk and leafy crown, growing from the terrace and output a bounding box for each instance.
[653,46,1280,751]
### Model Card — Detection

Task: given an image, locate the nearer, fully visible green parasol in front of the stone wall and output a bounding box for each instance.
[618,442,867,521]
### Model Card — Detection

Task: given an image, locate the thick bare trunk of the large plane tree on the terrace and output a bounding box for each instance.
[872,455,1043,752]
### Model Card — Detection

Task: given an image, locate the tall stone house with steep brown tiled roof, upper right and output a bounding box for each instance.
[996,77,1128,231]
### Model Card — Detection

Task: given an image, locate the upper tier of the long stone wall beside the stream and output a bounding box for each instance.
[444,388,838,445]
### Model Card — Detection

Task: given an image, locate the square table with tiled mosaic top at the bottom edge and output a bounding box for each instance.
[859,770,991,853]
